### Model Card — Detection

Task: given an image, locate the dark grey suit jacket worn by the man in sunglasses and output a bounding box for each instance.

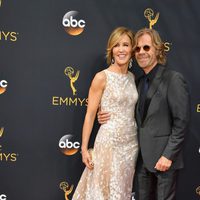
[136,66,189,172]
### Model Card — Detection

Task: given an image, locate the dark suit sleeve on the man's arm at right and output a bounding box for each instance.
[163,72,190,161]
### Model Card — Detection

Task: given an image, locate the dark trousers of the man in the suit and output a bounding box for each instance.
[135,159,178,200]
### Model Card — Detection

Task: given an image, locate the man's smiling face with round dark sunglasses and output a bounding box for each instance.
[135,33,158,74]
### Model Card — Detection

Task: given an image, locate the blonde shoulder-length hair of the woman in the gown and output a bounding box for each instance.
[106,26,135,65]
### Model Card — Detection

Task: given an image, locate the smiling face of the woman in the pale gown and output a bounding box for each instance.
[112,34,133,66]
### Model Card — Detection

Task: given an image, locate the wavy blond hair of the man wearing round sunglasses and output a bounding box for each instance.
[133,28,167,65]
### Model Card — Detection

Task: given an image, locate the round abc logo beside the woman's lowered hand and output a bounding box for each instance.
[59,135,80,156]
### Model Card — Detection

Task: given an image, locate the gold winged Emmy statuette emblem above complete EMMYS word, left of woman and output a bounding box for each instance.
[64,67,80,95]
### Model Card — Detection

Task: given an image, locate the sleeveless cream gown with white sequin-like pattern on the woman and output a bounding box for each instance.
[72,69,138,200]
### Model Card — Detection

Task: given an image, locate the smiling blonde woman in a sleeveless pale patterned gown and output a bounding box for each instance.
[72,27,138,200]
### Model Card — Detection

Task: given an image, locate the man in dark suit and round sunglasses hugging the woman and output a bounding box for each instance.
[98,28,189,200]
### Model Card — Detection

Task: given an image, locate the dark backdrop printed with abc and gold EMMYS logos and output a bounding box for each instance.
[0,0,200,200]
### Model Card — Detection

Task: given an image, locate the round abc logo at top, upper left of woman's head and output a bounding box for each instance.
[62,11,85,36]
